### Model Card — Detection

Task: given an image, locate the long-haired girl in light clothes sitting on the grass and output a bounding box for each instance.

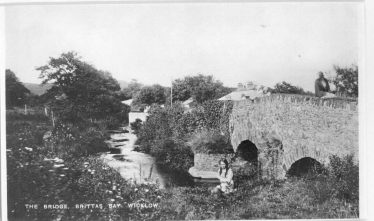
[212,159,234,193]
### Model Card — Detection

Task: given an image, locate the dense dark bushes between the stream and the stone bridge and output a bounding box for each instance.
[137,101,232,171]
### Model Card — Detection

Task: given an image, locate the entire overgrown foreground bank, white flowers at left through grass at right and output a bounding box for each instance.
[7,111,359,220]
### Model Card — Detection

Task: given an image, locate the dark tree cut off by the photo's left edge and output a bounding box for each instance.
[5,69,30,107]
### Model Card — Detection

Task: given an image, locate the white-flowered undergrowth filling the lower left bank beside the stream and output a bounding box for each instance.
[7,114,163,220]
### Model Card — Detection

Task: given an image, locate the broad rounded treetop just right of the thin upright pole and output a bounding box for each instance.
[173,74,231,103]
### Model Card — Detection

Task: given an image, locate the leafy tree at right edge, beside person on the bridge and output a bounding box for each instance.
[330,65,358,97]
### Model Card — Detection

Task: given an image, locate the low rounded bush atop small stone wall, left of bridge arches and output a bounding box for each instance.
[189,129,233,154]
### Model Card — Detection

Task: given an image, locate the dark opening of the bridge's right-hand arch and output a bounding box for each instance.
[286,157,326,177]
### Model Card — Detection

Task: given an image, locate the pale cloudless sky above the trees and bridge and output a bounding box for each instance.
[6,2,363,91]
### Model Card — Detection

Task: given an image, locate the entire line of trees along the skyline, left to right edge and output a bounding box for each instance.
[6,52,358,113]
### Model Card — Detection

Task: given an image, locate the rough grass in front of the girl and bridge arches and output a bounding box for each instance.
[161,175,359,220]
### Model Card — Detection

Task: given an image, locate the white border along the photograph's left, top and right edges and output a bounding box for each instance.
[0,0,374,220]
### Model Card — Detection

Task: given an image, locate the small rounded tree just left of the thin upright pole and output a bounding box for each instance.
[134,84,166,105]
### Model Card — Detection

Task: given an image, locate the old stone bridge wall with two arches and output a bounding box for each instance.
[229,94,359,179]
